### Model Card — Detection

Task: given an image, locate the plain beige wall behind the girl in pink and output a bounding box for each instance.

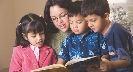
[0,0,46,72]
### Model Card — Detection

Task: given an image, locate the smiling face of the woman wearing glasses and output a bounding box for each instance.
[50,5,69,32]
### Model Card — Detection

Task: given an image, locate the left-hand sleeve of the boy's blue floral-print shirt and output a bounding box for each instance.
[58,36,70,61]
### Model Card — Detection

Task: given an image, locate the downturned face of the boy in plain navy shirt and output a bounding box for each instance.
[85,14,105,32]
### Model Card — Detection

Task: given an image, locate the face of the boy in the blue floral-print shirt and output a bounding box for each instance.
[69,14,88,34]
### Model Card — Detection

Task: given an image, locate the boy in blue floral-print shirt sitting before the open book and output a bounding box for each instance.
[57,1,108,71]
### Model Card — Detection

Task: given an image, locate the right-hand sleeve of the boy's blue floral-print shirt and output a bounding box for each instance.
[98,33,108,56]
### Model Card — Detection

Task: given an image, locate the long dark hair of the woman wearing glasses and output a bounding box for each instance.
[44,0,72,33]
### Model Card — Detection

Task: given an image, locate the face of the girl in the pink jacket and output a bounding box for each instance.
[25,31,45,47]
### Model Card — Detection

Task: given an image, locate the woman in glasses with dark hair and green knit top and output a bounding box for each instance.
[44,0,72,53]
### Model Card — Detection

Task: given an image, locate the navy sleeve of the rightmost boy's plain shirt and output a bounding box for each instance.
[112,31,133,61]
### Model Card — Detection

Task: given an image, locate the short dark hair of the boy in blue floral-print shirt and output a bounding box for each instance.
[68,1,82,17]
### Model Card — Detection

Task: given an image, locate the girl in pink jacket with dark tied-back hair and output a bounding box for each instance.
[9,13,57,72]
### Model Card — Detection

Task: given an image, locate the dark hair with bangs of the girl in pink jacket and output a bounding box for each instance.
[15,13,47,47]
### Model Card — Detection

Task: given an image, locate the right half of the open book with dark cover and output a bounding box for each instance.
[65,56,101,72]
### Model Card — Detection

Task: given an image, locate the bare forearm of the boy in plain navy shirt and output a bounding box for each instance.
[110,60,130,69]
